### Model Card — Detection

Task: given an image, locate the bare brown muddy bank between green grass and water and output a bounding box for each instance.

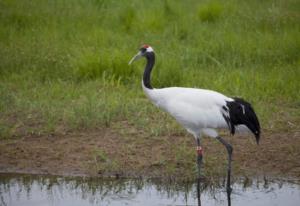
[0,129,300,177]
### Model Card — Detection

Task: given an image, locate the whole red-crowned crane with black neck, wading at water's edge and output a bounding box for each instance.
[129,44,261,191]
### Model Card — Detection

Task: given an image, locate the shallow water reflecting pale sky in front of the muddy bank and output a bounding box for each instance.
[0,174,300,206]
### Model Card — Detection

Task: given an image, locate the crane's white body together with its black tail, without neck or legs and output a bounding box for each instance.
[142,84,260,142]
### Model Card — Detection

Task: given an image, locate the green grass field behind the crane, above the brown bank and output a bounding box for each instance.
[0,0,300,138]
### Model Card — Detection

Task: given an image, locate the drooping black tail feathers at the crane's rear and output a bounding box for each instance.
[223,97,260,144]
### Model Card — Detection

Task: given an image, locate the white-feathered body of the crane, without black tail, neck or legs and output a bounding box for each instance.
[143,84,233,138]
